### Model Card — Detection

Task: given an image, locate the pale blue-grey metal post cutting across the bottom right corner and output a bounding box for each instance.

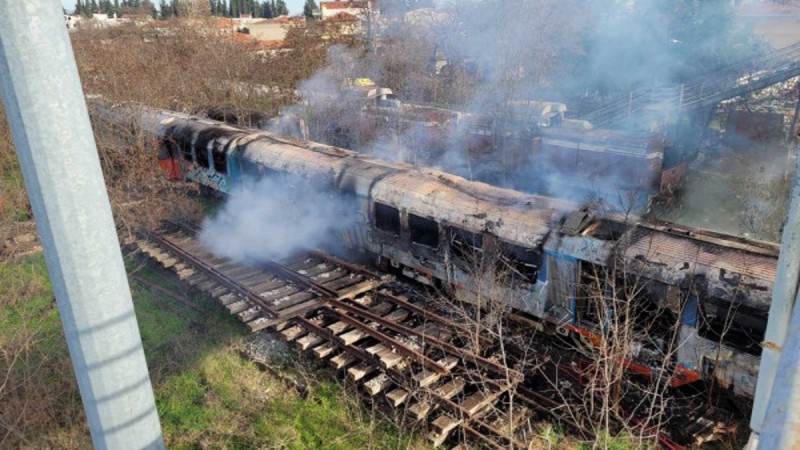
[758,290,800,450]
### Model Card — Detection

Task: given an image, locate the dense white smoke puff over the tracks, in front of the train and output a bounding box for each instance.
[200,176,353,262]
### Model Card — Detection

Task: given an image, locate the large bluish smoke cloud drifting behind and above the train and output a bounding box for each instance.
[264,0,768,213]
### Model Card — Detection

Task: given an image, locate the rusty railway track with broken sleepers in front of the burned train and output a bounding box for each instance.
[136,228,536,448]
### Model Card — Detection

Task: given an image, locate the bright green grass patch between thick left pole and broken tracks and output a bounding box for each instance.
[157,348,414,450]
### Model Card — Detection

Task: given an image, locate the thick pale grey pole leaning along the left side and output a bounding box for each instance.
[0,0,164,449]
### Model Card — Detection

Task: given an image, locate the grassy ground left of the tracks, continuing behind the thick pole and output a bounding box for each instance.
[0,254,420,449]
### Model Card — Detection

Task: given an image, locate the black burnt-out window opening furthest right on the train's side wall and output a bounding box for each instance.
[697,299,767,356]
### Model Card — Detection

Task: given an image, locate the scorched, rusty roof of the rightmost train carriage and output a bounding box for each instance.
[545,210,779,310]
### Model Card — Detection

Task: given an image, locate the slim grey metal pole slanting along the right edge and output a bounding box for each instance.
[748,134,800,442]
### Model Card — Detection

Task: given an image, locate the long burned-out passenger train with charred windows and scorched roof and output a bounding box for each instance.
[135,109,778,398]
